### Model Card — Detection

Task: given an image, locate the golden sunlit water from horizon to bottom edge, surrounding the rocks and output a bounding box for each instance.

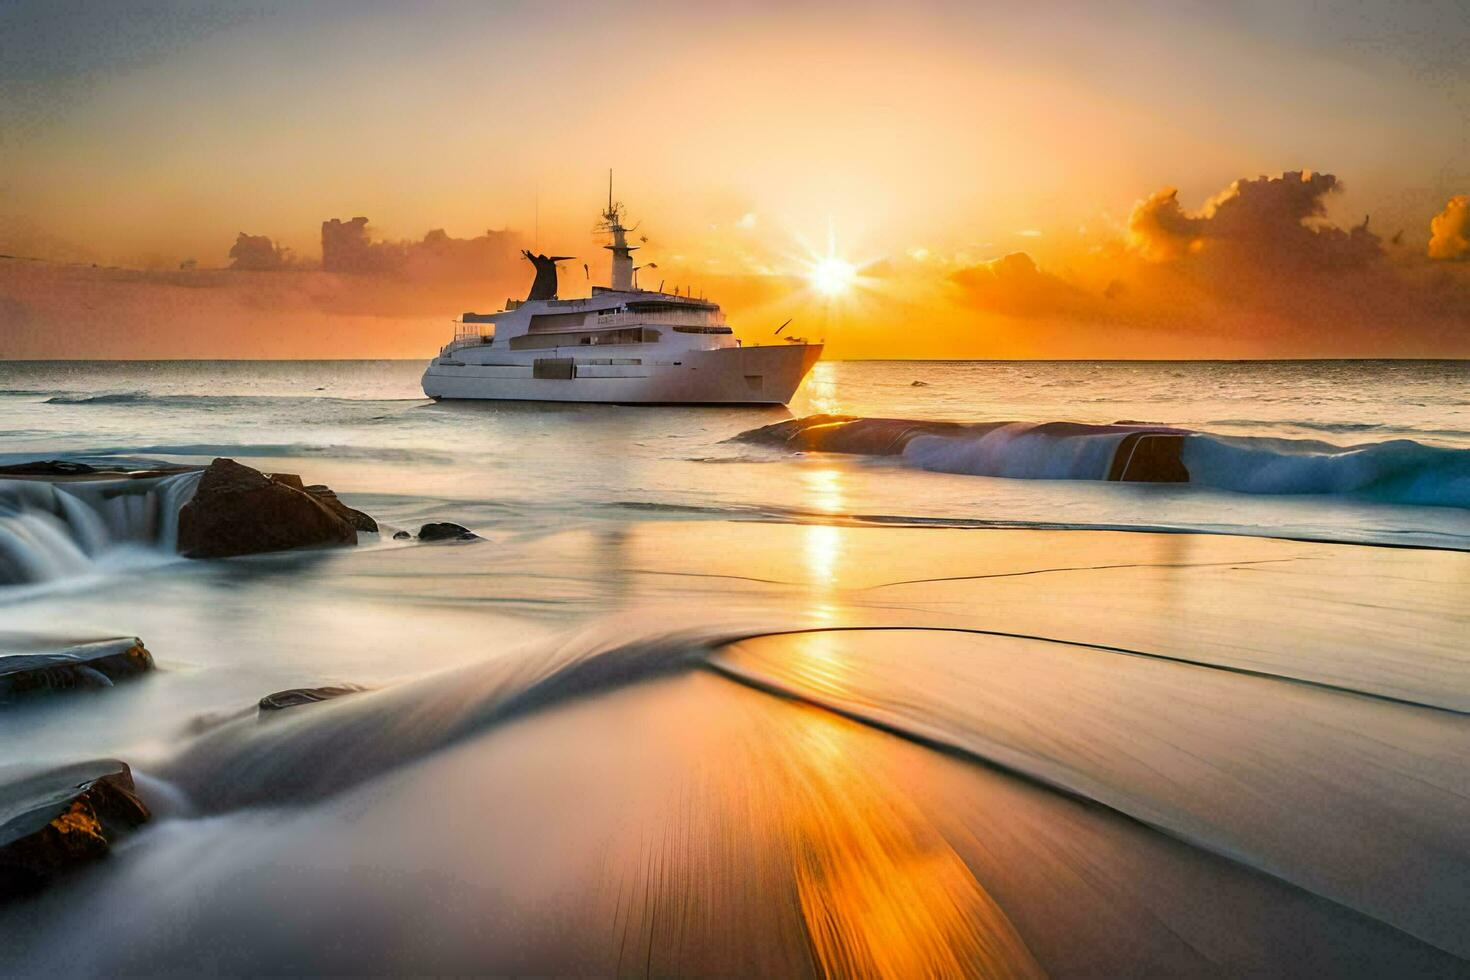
[0,361,1470,976]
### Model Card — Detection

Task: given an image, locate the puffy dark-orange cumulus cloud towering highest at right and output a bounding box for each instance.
[1127,170,1383,273]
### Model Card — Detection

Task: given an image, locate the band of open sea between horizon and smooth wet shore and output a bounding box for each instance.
[0,361,1470,548]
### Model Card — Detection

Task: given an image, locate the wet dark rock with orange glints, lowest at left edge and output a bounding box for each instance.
[0,760,148,902]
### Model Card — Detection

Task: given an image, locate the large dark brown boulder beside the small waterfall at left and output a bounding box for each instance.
[178,458,357,558]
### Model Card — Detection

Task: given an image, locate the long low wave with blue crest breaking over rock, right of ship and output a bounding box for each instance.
[736,416,1470,507]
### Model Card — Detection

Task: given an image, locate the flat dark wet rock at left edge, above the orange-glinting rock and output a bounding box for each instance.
[0,635,153,701]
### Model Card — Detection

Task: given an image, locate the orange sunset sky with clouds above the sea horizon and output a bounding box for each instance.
[0,3,1470,357]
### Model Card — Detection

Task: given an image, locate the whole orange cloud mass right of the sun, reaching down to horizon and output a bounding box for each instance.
[934,170,1470,357]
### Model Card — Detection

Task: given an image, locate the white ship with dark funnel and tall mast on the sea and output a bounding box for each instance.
[423,181,822,406]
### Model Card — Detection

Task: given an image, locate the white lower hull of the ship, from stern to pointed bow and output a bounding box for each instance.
[423,344,822,406]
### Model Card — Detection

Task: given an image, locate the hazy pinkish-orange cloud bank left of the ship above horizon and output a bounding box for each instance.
[0,219,531,359]
